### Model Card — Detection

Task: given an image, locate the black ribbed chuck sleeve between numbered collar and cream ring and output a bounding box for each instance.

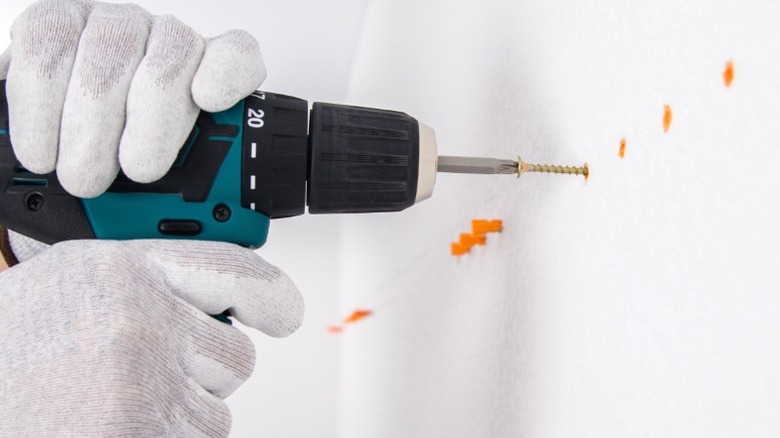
[308,103,420,214]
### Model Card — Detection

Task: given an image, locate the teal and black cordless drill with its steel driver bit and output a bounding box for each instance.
[0,81,584,248]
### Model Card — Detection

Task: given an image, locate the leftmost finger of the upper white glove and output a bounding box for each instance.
[6,0,91,174]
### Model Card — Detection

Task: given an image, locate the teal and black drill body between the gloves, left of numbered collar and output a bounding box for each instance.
[0,81,284,248]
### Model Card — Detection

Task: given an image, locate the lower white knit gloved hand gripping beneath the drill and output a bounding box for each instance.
[0,241,303,437]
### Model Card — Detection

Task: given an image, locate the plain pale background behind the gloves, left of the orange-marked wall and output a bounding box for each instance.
[0,0,366,438]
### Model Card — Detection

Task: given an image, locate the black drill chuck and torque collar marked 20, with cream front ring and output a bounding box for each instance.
[242,93,436,219]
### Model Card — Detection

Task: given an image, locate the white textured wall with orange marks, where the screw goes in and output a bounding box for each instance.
[340,0,780,437]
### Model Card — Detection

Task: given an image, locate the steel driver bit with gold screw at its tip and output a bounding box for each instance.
[438,156,589,178]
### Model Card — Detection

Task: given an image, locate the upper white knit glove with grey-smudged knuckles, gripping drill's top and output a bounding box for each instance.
[0,0,266,197]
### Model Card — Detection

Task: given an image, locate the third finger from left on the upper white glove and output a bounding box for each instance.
[119,16,206,183]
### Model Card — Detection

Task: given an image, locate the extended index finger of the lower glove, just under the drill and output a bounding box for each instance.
[147,241,304,337]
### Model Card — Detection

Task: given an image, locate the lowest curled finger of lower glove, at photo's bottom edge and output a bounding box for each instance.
[171,378,233,438]
